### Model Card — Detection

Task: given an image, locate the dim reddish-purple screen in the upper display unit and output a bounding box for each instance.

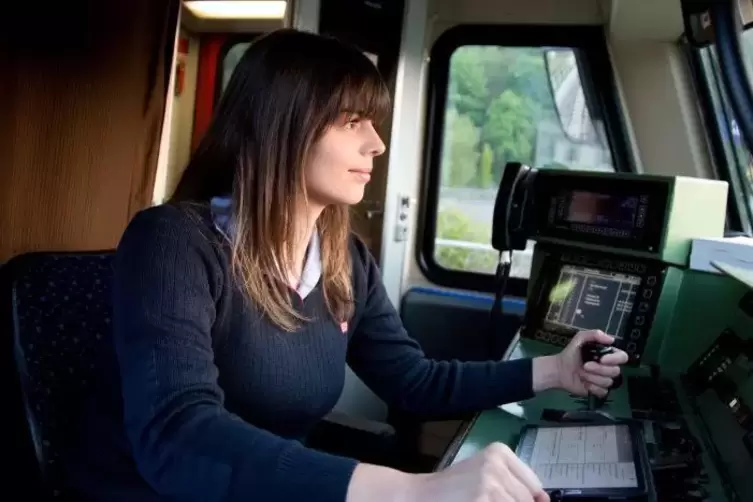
[564,190,639,230]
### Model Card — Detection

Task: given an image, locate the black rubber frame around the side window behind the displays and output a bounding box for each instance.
[414,24,635,297]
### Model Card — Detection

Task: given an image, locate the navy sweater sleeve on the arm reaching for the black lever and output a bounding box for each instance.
[348,238,534,415]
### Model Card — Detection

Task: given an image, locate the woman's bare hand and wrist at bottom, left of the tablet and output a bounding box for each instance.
[347,443,549,502]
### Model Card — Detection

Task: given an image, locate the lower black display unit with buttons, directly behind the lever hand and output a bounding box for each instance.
[521,245,667,364]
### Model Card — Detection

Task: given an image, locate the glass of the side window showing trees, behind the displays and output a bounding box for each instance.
[434,45,614,279]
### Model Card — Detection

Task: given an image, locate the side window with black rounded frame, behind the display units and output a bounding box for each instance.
[420,25,627,296]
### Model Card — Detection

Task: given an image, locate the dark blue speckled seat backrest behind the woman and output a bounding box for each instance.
[0,251,114,496]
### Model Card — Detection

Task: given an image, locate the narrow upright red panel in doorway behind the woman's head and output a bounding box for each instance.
[191,34,227,150]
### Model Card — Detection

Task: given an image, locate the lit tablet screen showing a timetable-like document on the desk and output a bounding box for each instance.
[529,424,638,489]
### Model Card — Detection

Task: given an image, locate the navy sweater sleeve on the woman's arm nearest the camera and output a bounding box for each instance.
[113,206,356,502]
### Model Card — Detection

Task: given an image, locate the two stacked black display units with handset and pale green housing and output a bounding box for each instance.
[492,163,727,366]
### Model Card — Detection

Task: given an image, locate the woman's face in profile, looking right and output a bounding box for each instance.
[305,114,386,207]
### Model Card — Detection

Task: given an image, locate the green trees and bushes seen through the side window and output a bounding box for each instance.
[435,46,555,273]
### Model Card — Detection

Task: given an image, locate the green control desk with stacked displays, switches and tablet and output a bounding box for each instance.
[439,171,753,501]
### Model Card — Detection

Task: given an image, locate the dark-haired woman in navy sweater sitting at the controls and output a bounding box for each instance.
[78,30,626,502]
